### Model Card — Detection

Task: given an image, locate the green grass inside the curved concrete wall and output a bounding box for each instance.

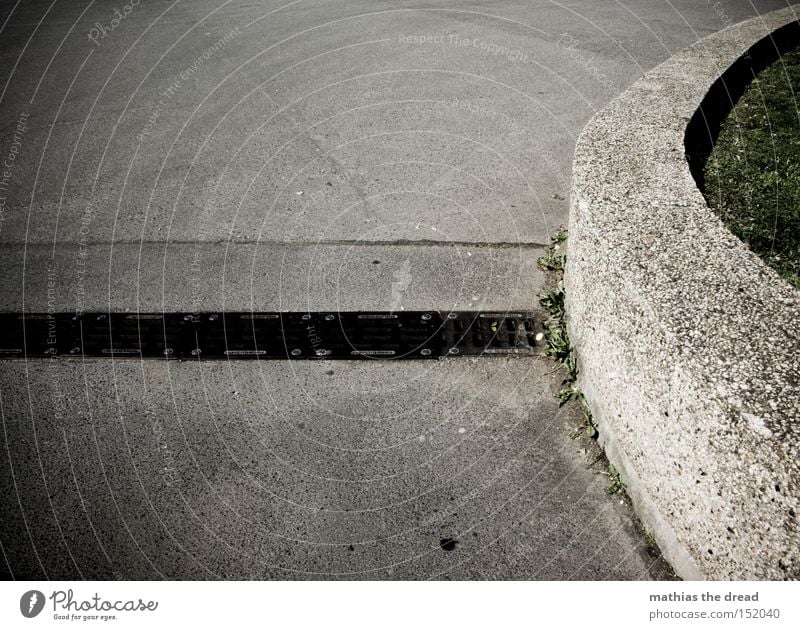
[705,51,800,288]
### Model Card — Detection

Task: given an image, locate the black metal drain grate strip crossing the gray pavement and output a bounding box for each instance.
[0,311,539,360]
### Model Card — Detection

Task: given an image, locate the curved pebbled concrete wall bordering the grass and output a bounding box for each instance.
[565,5,800,579]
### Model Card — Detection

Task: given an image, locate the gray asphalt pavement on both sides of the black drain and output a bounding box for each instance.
[0,0,785,579]
